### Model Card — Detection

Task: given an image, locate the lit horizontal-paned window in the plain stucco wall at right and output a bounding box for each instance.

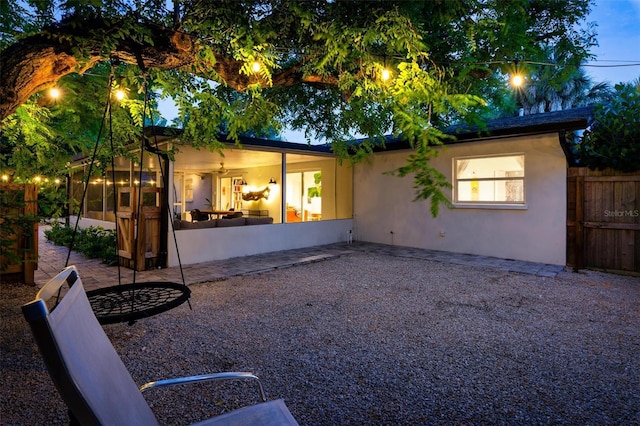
[454,154,525,204]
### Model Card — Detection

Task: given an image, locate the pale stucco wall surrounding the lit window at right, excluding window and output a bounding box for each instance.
[354,133,567,265]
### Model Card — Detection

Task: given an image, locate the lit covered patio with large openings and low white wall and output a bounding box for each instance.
[70,128,353,267]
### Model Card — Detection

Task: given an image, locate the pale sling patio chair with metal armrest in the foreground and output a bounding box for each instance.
[22,266,297,425]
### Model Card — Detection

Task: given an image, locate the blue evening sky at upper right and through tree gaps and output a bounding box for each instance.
[160,0,640,142]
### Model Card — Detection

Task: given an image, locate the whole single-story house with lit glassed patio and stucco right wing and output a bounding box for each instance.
[71,108,592,266]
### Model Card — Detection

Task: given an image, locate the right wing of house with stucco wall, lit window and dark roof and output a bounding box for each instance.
[353,107,592,265]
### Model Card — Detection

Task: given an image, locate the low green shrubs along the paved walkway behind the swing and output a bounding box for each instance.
[44,222,118,265]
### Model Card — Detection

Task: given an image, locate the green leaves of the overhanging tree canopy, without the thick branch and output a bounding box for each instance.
[0,0,595,212]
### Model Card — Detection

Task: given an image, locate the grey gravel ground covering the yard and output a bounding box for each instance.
[0,253,640,425]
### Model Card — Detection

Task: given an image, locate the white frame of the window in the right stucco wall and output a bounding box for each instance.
[452,152,528,210]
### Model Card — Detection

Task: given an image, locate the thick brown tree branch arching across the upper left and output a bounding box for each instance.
[0,21,338,121]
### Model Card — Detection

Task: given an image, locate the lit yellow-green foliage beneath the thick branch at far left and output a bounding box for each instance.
[0,64,158,180]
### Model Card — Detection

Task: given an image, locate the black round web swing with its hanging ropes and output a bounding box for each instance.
[65,64,191,324]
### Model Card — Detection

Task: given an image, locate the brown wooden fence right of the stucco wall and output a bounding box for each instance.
[567,168,640,275]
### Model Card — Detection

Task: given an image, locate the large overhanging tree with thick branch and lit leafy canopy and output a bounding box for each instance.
[0,0,594,211]
